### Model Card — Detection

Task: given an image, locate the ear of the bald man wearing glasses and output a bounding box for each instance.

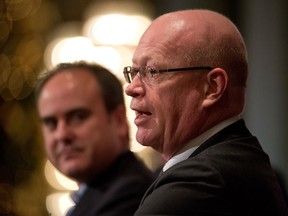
[203,68,229,108]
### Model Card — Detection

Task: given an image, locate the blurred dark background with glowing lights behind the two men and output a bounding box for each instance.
[0,0,288,216]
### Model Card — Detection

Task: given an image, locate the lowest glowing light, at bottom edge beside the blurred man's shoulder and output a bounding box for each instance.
[46,192,74,216]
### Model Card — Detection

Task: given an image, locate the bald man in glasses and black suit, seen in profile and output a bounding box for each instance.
[124,10,288,216]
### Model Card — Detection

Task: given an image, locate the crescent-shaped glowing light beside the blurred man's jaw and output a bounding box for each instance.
[44,160,78,191]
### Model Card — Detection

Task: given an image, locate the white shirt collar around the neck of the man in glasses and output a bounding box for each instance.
[163,116,240,172]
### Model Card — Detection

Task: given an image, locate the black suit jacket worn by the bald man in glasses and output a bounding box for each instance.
[135,120,288,216]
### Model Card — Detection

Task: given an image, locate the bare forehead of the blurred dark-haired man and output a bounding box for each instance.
[38,70,102,110]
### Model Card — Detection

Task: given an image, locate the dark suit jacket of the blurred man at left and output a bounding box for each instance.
[71,151,155,216]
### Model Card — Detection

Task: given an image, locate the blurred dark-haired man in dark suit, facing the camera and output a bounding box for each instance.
[36,61,153,216]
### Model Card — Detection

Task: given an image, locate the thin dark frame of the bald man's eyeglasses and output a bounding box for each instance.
[123,66,214,83]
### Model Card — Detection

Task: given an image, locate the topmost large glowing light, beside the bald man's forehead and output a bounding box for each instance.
[83,14,151,45]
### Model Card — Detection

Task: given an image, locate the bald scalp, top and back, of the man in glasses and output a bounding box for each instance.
[139,10,248,86]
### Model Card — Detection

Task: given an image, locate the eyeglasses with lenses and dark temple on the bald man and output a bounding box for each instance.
[123,66,213,84]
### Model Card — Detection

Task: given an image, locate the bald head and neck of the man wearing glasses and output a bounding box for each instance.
[125,10,247,159]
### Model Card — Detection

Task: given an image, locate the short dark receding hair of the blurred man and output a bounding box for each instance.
[35,61,124,112]
